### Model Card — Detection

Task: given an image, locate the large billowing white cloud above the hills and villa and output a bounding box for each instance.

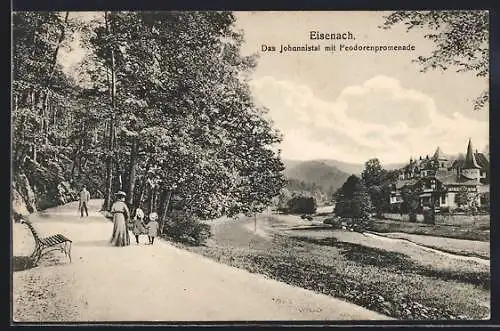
[251,76,488,163]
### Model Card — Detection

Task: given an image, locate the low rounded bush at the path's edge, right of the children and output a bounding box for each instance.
[163,213,212,246]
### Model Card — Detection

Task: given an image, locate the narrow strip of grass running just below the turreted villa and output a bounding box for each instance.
[371,219,490,241]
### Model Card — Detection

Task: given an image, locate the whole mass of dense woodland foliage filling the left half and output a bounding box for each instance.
[12,11,284,244]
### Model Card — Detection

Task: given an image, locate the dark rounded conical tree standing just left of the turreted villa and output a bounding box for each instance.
[334,175,371,228]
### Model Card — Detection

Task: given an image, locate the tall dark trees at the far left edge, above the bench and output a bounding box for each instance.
[12,12,87,208]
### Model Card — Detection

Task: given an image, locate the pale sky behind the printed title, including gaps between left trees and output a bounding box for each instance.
[57,11,489,163]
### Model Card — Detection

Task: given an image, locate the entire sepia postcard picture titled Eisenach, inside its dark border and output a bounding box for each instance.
[10,10,493,324]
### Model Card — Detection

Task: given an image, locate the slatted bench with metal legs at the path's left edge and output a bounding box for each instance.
[21,218,73,265]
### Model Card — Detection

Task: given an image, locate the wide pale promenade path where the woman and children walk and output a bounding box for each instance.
[13,200,387,321]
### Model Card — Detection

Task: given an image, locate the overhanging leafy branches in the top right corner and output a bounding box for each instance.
[382,10,489,109]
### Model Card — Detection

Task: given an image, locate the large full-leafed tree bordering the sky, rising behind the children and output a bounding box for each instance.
[85,12,283,218]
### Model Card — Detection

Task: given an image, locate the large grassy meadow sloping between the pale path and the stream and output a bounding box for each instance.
[174,218,490,320]
